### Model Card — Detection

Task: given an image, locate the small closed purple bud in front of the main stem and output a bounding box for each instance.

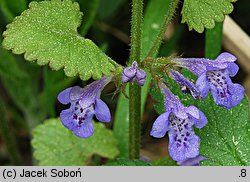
[122,61,147,86]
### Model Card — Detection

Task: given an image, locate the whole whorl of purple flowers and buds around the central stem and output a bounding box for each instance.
[58,53,244,165]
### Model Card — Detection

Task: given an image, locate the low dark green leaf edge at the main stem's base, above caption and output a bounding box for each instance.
[106,158,151,166]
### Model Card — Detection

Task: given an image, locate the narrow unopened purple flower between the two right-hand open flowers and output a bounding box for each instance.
[169,69,201,99]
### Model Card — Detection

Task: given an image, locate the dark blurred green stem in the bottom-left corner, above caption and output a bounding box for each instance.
[0,101,22,165]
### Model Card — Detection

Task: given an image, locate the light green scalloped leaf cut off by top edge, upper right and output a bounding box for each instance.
[181,0,237,33]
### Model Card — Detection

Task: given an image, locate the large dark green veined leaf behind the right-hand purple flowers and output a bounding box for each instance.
[150,70,250,166]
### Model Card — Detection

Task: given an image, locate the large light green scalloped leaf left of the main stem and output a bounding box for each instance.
[3,0,114,80]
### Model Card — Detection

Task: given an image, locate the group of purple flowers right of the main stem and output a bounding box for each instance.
[150,53,244,165]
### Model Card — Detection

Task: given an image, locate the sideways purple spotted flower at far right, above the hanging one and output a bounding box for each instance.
[173,53,245,109]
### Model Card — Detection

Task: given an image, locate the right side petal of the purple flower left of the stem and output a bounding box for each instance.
[95,99,111,122]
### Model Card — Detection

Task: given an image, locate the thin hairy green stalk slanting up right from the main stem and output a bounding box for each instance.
[147,0,179,58]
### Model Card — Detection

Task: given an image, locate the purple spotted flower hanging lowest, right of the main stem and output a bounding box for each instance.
[150,83,208,161]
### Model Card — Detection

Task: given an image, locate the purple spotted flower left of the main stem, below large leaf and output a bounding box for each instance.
[57,76,111,138]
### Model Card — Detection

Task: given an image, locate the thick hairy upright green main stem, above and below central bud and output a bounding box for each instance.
[129,0,143,159]
